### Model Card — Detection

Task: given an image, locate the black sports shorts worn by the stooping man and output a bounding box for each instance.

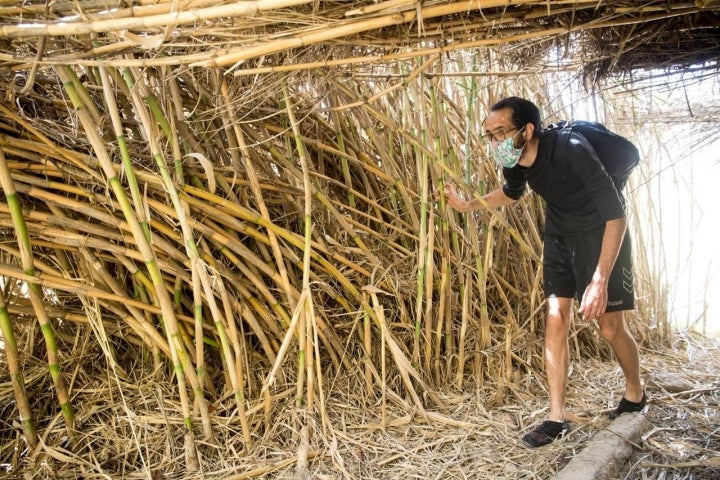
[543,227,635,312]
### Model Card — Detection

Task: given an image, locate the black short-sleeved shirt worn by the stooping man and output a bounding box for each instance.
[503,130,625,236]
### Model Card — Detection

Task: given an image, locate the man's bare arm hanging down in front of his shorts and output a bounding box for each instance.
[579,218,627,320]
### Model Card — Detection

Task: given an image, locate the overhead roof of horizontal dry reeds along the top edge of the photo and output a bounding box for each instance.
[0,0,720,76]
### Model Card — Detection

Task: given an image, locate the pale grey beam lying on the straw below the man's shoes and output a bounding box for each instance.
[554,413,651,480]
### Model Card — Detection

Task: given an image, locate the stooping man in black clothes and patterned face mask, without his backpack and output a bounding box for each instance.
[444,97,647,448]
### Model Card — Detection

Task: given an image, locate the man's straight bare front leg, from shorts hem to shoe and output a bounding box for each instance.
[545,298,572,422]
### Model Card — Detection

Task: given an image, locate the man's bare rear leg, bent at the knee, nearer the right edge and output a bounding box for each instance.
[598,311,643,402]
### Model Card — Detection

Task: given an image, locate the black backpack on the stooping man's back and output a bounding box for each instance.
[546,120,640,192]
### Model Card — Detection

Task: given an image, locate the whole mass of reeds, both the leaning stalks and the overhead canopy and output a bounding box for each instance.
[0,0,720,478]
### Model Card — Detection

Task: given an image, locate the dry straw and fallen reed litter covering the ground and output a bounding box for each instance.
[0,330,720,480]
